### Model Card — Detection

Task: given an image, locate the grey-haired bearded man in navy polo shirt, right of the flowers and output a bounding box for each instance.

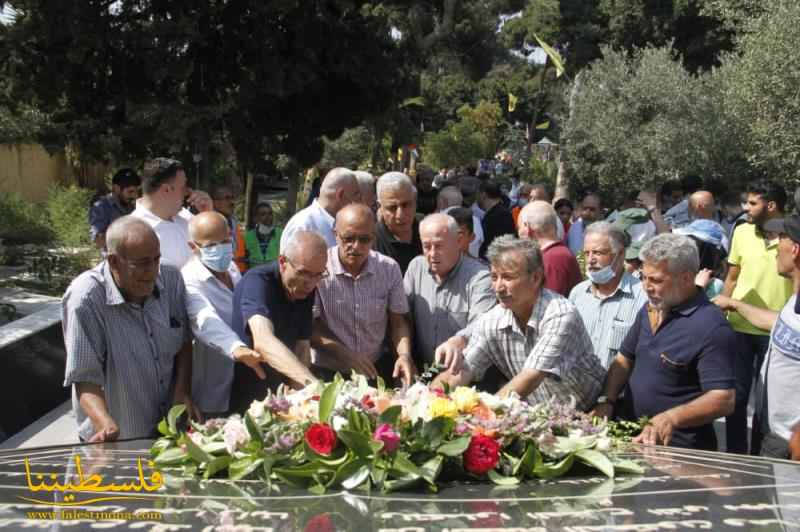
[595,233,738,450]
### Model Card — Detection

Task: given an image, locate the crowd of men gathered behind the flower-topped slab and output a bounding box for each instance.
[70,163,800,459]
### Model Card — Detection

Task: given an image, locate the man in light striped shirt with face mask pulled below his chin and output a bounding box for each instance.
[569,222,647,369]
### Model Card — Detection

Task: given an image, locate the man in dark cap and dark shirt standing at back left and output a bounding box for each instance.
[89,168,142,249]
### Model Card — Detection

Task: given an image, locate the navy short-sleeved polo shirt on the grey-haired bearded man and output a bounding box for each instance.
[620,290,739,450]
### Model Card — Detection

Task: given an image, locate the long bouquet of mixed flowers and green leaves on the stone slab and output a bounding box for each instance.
[151,375,642,494]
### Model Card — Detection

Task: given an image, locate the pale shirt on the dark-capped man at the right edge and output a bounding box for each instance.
[756,294,800,442]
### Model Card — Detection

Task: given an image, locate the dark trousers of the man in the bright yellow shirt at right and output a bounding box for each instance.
[725,332,769,454]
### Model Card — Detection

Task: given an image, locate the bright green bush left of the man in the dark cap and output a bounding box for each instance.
[47,185,94,247]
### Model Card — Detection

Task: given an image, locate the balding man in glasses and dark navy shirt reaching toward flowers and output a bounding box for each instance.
[231,230,328,412]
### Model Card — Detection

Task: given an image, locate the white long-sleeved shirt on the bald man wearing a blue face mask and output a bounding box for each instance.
[181,256,244,412]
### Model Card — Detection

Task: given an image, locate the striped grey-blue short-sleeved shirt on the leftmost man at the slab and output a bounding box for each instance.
[61,262,191,440]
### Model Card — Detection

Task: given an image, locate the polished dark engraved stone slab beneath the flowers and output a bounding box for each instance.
[0,441,800,532]
